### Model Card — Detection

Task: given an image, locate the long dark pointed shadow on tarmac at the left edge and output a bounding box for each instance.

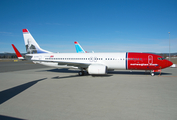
[0,78,47,105]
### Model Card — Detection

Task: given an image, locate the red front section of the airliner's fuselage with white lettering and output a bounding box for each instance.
[127,52,169,70]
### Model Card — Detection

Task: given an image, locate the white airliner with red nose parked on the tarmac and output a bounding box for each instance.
[22,29,173,76]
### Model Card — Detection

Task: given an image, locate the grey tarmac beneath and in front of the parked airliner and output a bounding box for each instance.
[0,62,177,120]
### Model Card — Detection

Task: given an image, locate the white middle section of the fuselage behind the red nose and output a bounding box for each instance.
[30,52,127,69]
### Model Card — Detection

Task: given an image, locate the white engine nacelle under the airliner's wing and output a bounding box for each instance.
[88,65,107,74]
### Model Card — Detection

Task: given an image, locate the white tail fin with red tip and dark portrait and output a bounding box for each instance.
[22,29,51,54]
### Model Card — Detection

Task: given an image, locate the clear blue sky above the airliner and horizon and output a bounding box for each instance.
[0,0,177,53]
